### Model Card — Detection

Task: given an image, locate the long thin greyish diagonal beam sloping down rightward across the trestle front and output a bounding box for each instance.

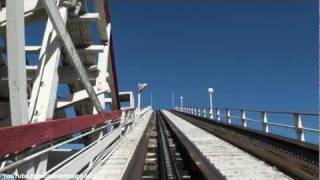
[41,0,104,113]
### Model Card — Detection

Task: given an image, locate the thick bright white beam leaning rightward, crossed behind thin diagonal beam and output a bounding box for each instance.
[27,1,68,174]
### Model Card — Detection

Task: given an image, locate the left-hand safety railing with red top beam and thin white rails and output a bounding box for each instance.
[0,108,150,179]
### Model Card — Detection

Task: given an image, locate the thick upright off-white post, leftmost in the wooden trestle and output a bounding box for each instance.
[6,0,28,126]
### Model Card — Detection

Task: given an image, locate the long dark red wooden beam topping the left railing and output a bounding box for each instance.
[0,111,121,158]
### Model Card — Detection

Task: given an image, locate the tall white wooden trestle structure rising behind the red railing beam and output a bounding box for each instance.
[0,0,124,177]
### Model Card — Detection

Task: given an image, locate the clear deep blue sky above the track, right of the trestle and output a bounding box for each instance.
[110,0,318,112]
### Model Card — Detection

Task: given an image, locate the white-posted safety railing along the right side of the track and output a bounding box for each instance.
[175,107,320,142]
